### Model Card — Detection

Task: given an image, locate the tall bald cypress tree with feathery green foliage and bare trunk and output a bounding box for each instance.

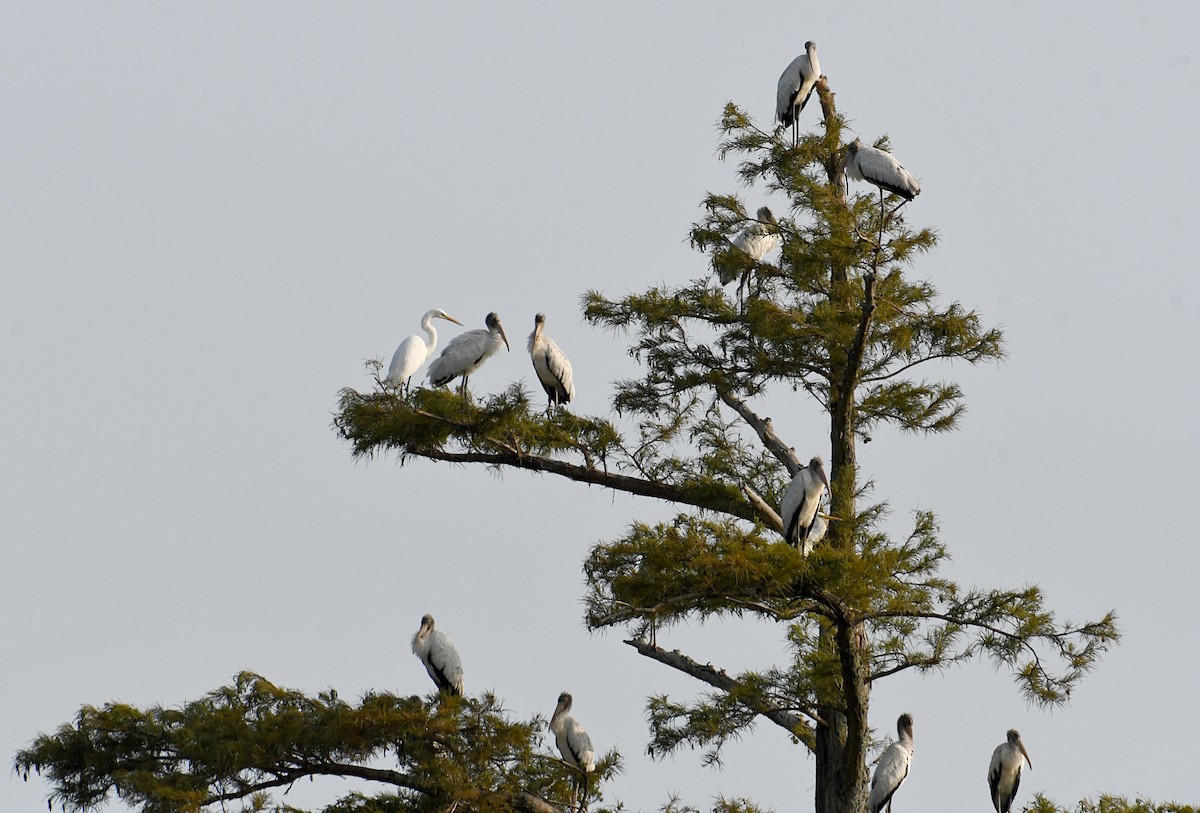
[16,79,1118,813]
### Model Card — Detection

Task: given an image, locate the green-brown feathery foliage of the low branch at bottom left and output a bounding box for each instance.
[13,673,618,813]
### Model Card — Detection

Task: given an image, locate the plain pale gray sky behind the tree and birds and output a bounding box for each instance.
[0,2,1200,812]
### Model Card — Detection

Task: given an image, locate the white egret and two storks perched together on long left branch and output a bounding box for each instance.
[384,308,575,411]
